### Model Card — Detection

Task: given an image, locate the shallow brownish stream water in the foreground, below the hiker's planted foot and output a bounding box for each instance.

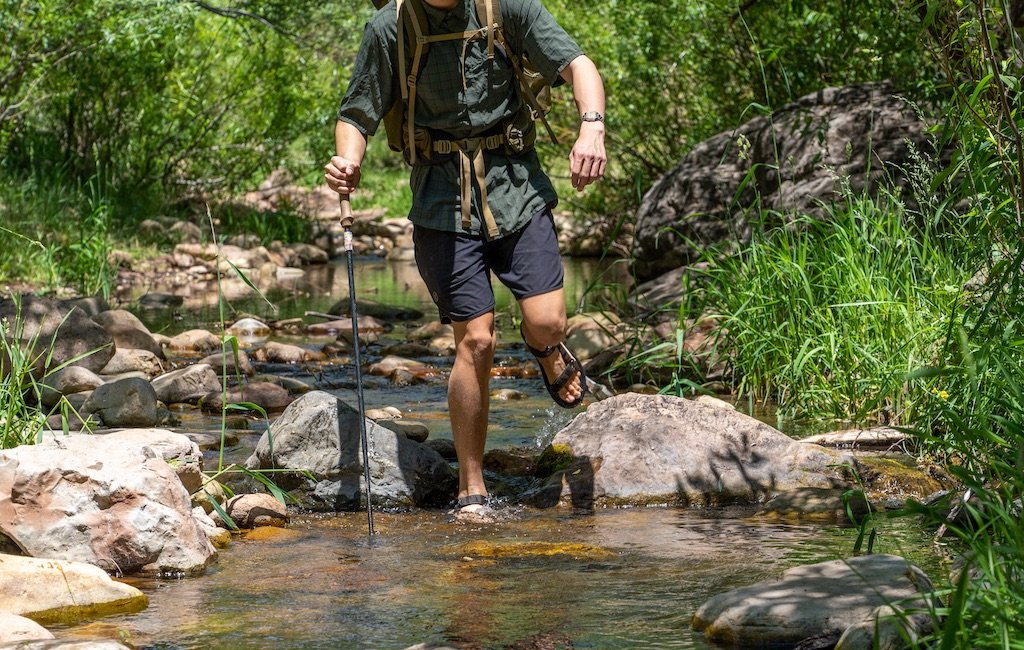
[55,508,938,649]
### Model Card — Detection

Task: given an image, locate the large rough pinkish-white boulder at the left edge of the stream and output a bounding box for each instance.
[0,431,216,574]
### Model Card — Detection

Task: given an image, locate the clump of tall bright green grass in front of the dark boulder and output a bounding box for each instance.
[709,190,970,421]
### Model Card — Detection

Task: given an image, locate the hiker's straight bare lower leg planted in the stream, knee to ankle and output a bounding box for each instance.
[449,311,495,497]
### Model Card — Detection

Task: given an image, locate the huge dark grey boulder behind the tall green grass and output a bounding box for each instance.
[634,84,928,279]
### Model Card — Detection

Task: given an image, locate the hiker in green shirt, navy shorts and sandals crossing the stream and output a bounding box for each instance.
[325,0,606,519]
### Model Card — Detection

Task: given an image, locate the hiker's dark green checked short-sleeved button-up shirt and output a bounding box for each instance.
[338,0,583,235]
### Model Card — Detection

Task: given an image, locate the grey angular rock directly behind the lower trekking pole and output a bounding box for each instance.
[246,391,456,510]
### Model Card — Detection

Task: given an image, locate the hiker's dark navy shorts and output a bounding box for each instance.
[413,209,563,322]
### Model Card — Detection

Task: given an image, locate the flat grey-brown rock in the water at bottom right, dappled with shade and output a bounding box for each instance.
[692,555,937,648]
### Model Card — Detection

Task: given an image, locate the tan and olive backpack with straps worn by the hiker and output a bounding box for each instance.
[374,0,558,165]
